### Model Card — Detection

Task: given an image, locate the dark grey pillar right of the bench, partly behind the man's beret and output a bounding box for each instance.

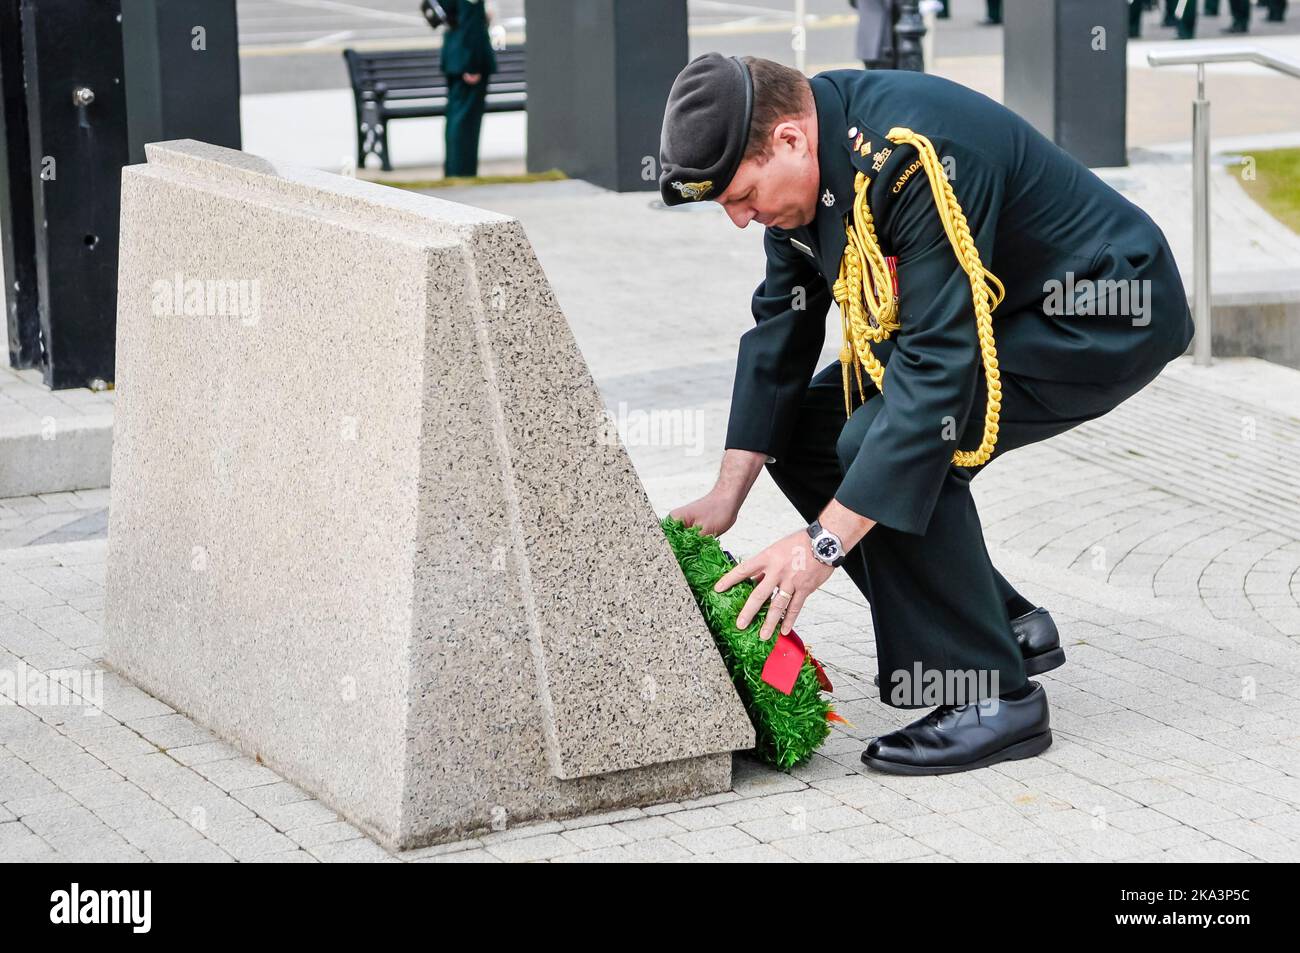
[525,0,688,192]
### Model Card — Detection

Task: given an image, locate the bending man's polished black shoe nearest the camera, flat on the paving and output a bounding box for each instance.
[862,681,1052,775]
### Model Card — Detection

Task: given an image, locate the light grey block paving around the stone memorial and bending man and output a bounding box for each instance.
[0,173,1300,862]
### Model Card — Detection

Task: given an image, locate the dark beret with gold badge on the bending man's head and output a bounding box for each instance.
[659,53,754,205]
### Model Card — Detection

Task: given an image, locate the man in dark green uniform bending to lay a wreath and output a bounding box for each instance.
[659,53,1192,774]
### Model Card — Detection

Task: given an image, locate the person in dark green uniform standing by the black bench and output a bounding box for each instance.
[441,0,497,178]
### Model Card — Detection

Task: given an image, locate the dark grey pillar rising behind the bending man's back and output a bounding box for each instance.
[1002,0,1128,168]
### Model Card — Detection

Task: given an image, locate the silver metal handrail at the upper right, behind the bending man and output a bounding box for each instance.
[1147,46,1300,365]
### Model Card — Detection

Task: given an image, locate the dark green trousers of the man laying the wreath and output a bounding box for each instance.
[767,351,1156,707]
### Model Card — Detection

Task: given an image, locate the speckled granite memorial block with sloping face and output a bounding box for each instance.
[105,140,754,848]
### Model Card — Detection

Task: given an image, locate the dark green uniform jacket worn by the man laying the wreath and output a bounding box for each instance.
[725,70,1192,533]
